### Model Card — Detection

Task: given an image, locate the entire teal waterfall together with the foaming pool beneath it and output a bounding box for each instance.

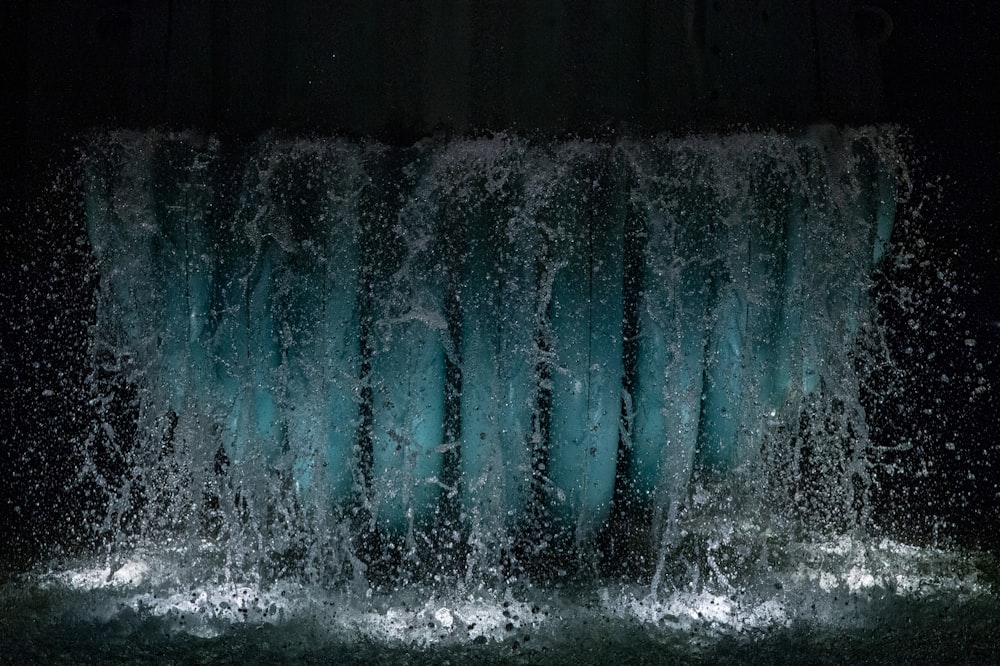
[0,127,998,663]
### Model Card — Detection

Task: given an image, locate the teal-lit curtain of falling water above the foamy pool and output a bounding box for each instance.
[84,127,901,579]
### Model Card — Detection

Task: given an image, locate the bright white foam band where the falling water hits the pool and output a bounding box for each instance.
[31,537,989,646]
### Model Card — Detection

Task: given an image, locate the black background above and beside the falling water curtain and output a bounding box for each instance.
[0,0,1000,569]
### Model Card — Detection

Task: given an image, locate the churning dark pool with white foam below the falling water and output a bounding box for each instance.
[0,538,1000,664]
